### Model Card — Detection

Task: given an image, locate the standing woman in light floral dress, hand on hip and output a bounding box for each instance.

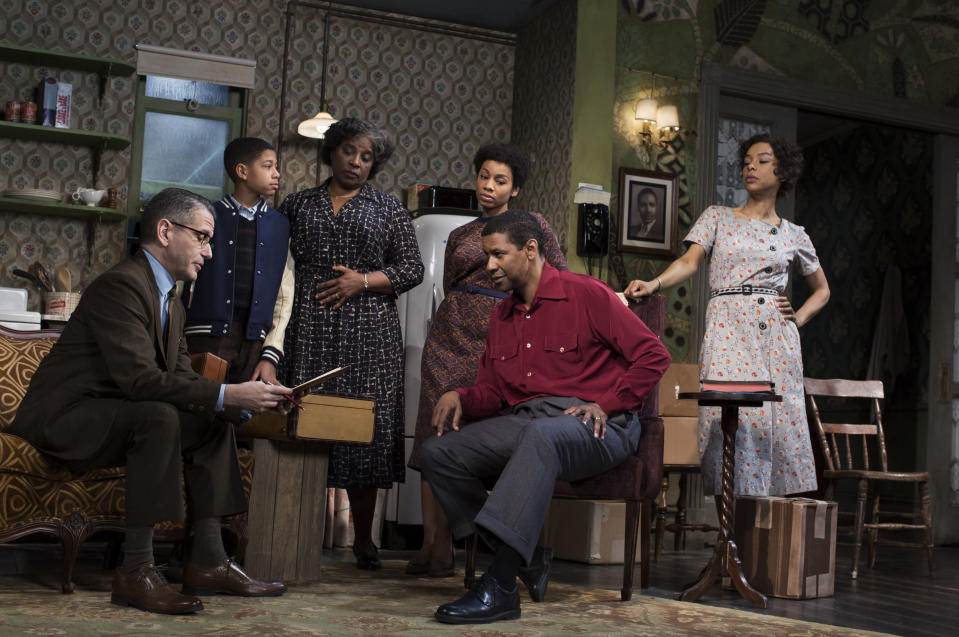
[626,135,829,495]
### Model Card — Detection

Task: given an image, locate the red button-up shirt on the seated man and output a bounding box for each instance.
[456,263,670,420]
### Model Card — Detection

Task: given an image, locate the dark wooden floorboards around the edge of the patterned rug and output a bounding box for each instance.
[0,542,959,637]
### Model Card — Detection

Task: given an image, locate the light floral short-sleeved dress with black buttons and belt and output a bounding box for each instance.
[684,206,819,495]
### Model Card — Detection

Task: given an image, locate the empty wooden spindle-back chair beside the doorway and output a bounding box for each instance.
[803,378,933,579]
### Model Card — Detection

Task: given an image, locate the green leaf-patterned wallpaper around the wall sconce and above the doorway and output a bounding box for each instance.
[610,0,959,361]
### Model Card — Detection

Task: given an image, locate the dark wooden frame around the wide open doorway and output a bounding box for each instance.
[690,62,959,541]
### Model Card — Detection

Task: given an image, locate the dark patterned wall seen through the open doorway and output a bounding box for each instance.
[794,124,933,402]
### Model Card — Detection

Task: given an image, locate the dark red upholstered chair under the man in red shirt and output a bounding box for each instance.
[464,294,666,601]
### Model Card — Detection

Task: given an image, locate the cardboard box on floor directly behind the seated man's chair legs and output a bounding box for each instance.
[539,498,643,564]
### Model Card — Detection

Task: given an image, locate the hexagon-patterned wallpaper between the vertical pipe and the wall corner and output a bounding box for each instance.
[282,7,514,198]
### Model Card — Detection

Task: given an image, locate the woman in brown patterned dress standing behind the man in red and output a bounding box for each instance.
[406,144,567,577]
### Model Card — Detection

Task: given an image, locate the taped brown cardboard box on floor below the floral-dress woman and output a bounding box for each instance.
[734,496,838,599]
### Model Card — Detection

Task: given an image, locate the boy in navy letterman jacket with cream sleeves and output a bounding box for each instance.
[183,137,293,383]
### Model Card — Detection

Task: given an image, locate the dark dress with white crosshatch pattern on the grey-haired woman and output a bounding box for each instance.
[280,182,423,489]
